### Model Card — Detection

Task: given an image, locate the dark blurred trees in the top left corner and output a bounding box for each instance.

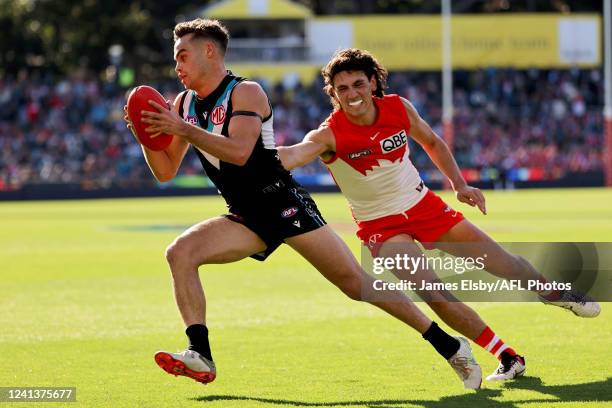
[0,0,216,78]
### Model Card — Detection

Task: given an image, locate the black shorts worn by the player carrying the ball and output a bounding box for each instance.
[225,185,326,261]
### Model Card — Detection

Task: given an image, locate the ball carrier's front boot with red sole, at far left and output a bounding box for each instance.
[155,350,217,384]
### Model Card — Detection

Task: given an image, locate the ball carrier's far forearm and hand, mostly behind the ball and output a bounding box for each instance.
[124,94,189,182]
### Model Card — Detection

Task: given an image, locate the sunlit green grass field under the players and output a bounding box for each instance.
[0,189,612,408]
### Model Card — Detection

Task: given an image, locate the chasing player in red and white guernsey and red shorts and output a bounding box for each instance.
[278,48,600,380]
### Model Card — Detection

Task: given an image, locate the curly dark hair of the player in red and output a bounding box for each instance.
[321,48,388,110]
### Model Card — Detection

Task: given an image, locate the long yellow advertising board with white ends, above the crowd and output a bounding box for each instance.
[308,14,601,70]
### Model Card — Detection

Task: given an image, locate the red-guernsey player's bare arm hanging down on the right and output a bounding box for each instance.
[402,98,487,215]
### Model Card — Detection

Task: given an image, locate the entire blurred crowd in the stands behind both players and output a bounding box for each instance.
[0,69,603,190]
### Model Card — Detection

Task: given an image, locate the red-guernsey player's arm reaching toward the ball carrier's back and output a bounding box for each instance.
[277,126,336,170]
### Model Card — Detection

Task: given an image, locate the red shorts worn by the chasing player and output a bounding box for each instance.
[357,190,465,256]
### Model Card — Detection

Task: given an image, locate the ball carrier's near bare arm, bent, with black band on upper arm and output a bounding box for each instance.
[143,82,270,166]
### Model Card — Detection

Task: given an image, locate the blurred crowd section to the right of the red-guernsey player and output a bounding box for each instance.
[390,69,604,179]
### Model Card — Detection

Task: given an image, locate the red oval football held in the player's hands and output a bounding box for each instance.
[127,85,173,151]
